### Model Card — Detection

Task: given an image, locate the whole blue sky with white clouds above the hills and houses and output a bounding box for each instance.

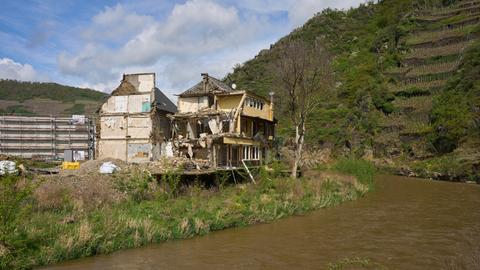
[0,0,364,97]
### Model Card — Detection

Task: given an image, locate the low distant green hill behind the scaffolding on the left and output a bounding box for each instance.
[0,80,107,115]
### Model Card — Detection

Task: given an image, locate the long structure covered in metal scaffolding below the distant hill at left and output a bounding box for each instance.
[0,115,95,160]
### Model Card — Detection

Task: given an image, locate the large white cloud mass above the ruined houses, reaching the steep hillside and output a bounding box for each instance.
[57,0,363,94]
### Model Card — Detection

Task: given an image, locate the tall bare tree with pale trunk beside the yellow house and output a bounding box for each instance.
[272,40,333,178]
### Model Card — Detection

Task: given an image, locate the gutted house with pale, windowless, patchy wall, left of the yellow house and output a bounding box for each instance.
[98,73,177,163]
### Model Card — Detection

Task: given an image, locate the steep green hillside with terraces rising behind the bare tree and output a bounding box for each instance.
[225,0,480,179]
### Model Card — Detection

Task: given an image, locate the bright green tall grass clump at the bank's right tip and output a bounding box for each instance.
[333,157,377,189]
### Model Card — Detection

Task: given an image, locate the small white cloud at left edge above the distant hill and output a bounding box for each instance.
[0,58,45,81]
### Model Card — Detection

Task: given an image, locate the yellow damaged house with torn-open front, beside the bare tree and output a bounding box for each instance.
[170,74,275,167]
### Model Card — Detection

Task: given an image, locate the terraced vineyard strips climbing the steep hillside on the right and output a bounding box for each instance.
[375,1,480,159]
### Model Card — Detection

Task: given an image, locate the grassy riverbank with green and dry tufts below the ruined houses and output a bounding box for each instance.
[0,160,373,269]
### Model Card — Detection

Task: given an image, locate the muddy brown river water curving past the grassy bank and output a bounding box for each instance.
[43,176,480,270]
